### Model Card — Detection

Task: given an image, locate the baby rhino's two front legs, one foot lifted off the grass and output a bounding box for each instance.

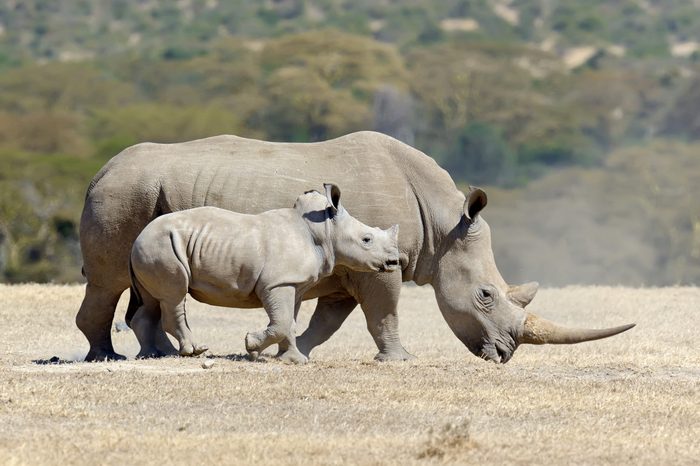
[245,286,308,364]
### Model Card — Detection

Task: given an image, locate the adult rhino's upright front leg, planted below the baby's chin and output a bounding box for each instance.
[357,272,415,361]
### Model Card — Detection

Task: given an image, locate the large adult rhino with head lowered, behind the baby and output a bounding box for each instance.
[76,132,633,363]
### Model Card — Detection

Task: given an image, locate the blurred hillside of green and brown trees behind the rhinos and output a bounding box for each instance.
[0,0,700,286]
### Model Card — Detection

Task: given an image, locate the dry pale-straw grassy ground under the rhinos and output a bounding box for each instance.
[0,285,700,465]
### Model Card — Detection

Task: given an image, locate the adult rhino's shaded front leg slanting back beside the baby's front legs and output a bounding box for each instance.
[297,293,357,357]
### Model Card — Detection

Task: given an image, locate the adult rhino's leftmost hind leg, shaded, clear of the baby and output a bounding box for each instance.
[75,283,126,361]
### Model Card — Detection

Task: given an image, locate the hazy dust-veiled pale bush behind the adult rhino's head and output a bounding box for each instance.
[484,140,700,286]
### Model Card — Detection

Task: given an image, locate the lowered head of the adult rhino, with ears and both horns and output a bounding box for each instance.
[433,188,634,363]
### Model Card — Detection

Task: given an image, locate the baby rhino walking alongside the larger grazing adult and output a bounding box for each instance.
[131,184,399,363]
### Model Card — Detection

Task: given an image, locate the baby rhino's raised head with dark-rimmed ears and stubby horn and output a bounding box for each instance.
[295,184,399,272]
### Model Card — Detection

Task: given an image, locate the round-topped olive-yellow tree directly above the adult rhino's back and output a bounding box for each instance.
[253,31,405,141]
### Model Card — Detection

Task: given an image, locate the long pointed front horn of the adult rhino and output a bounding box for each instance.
[518,312,636,345]
